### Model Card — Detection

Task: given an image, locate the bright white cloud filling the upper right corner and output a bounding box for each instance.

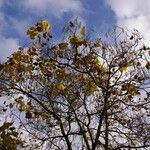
[106,0,150,44]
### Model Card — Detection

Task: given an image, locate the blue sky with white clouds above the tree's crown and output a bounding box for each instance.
[0,0,150,62]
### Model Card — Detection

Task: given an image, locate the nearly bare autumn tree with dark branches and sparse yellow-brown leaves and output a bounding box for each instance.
[0,20,150,150]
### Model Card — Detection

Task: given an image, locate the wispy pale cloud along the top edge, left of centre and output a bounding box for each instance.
[22,0,82,16]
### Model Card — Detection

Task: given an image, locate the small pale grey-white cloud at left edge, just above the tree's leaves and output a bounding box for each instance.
[0,36,19,62]
